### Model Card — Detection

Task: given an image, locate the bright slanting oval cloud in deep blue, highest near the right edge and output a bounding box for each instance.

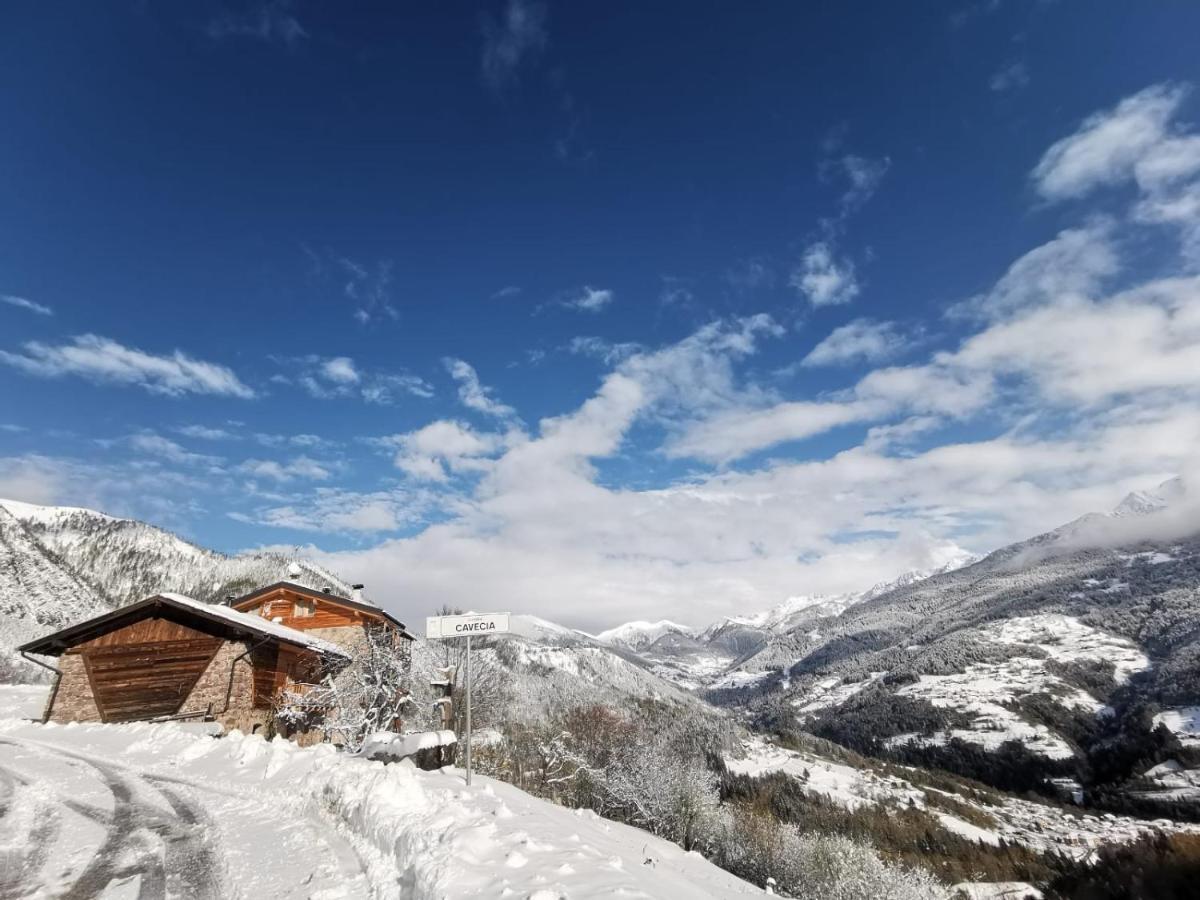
[1033,84,1186,200]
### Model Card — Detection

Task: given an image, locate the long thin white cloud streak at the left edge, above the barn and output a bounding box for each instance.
[0,335,254,398]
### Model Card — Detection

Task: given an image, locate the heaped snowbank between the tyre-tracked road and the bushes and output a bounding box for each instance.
[0,720,762,900]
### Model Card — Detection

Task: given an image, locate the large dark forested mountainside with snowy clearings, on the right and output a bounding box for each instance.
[713,480,1200,801]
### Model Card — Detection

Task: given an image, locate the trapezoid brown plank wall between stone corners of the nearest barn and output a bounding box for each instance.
[83,638,223,722]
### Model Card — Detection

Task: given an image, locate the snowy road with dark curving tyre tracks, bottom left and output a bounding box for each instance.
[0,737,373,900]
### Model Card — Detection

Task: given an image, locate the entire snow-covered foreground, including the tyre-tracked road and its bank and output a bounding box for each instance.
[0,691,762,900]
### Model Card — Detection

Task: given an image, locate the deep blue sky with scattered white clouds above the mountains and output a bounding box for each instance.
[0,0,1200,626]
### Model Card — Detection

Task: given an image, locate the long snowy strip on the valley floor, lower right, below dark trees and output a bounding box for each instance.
[725,738,1200,858]
